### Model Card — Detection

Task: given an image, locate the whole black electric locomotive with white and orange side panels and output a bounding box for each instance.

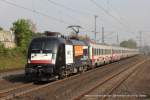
[25,33,91,81]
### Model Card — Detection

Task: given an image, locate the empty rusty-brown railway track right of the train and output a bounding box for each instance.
[73,58,150,100]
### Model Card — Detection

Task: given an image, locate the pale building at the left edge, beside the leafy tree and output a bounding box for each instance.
[0,31,16,48]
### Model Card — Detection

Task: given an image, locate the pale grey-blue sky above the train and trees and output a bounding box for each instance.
[0,0,150,45]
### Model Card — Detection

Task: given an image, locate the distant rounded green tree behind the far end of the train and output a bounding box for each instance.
[120,39,137,48]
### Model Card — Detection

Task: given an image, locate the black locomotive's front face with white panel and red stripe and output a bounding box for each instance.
[25,38,57,81]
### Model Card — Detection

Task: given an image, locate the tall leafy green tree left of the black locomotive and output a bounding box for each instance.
[12,19,33,51]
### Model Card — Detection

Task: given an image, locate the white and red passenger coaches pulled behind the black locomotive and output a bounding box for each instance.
[89,43,139,66]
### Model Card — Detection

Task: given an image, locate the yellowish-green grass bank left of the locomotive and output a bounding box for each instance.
[0,54,26,72]
